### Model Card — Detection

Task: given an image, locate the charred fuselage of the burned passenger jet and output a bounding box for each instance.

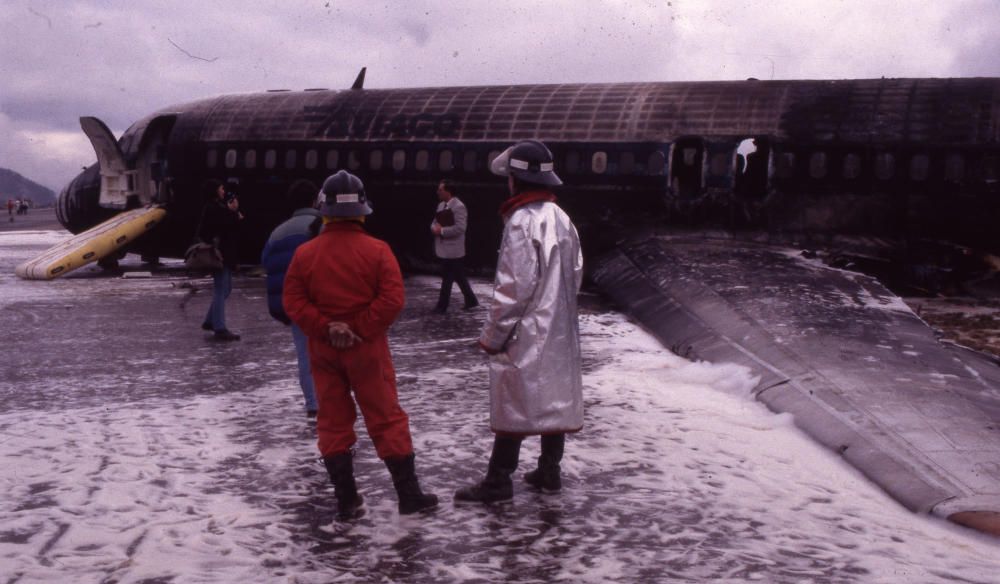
[59,78,1000,265]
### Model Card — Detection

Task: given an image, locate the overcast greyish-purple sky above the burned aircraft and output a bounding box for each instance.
[0,0,1000,190]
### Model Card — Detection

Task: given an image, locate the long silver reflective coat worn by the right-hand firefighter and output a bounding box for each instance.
[479,202,583,435]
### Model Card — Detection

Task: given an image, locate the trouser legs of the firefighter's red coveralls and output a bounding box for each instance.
[309,335,413,459]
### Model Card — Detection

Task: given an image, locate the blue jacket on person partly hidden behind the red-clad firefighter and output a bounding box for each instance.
[260,209,322,324]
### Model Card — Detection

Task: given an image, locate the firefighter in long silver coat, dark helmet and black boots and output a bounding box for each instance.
[455,140,583,503]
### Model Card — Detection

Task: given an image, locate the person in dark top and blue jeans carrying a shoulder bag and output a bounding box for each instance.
[198,183,243,341]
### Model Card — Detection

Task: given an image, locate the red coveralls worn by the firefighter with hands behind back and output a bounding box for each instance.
[283,222,413,458]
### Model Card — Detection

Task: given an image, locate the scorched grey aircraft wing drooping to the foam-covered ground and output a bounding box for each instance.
[594,236,1000,533]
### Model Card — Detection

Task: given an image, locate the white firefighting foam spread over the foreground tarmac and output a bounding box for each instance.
[0,234,1000,583]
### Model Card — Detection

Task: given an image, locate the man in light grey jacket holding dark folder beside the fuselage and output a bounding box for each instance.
[431,179,479,314]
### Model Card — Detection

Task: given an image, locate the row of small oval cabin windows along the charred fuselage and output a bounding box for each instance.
[205,147,1000,183]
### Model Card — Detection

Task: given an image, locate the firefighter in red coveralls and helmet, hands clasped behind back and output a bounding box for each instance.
[283,170,438,520]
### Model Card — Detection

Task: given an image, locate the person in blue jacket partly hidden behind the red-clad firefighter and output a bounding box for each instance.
[260,184,323,418]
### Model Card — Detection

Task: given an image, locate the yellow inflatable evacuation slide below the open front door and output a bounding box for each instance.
[15,207,167,280]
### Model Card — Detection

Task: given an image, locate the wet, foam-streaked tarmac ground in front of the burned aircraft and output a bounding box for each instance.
[0,229,1000,584]
